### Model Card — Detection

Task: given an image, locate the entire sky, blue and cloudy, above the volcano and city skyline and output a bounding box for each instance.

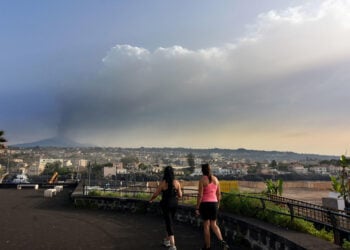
[0,0,350,155]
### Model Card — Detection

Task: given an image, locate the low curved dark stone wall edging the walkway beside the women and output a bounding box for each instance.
[72,195,341,250]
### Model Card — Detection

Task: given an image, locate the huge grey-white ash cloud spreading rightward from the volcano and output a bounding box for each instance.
[59,1,350,154]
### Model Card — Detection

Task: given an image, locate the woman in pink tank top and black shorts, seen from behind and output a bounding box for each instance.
[196,164,228,249]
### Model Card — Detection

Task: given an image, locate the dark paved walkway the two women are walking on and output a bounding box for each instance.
[0,189,202,250]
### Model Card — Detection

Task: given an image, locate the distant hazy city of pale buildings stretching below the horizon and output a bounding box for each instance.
[0,136,340,183]
